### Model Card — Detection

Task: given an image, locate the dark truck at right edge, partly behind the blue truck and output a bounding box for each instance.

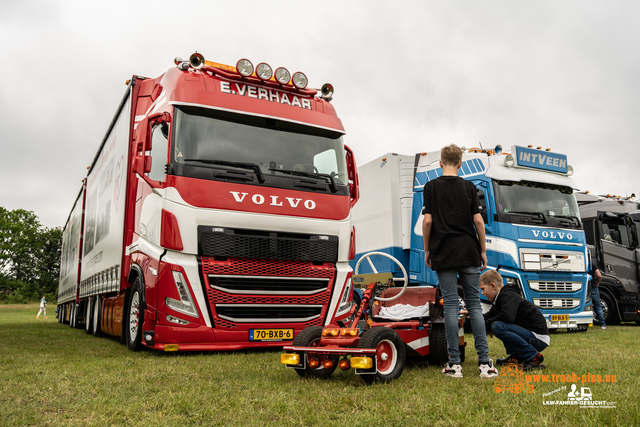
[576,193,640,325]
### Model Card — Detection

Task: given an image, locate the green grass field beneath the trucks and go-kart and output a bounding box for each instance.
[0,304,640,427]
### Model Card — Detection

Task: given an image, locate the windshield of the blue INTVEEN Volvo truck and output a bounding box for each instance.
[494,181,582,228]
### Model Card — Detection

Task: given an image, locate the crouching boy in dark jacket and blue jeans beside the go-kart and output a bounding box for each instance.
[480,270,551,371]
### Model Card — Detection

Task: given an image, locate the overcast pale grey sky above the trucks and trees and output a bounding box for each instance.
[0,0,640,227]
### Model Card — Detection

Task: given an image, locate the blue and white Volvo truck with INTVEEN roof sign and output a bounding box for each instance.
[353,146,593,331]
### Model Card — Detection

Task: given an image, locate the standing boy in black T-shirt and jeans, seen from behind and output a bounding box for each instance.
[422,144,498,378]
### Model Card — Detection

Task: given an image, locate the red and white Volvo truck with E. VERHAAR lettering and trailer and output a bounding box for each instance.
[58,54,358,351]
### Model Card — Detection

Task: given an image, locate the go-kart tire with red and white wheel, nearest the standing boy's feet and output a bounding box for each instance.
[358,326,406,384]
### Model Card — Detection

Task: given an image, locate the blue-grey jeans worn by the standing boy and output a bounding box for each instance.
[436,267,489,364]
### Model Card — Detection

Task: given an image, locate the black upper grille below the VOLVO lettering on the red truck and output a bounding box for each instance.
[198,226,338,263]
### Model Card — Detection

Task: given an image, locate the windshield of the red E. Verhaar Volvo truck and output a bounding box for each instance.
[171,107,348,193]
